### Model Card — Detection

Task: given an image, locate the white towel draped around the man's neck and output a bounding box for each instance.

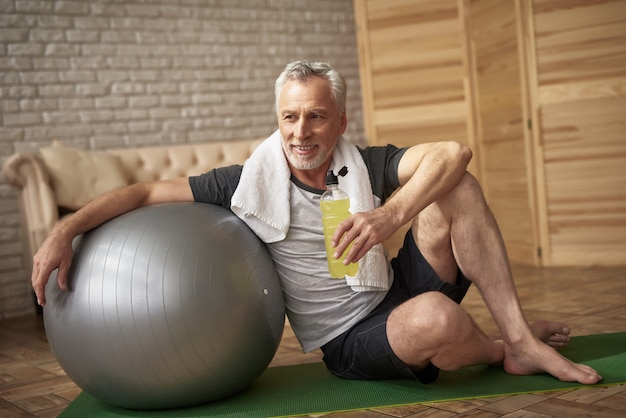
[230,131,391,292]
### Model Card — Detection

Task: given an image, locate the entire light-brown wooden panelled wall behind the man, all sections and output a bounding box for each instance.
[354,0,626,265]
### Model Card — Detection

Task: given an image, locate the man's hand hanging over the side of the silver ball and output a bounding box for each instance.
[31,231,73,306]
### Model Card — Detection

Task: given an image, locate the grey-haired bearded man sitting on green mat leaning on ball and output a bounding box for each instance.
[32,61,601,384]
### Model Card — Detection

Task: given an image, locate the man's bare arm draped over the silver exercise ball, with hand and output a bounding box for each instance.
[31,177,194,306]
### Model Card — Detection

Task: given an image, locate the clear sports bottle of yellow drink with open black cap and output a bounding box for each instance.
[320,167,359,279]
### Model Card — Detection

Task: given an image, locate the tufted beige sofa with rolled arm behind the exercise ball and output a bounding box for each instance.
[2,139,262,274]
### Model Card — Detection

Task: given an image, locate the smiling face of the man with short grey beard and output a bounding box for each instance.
[278,77,347,174]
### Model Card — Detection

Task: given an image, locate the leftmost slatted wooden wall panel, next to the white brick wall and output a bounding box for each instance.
[354,0,473,171]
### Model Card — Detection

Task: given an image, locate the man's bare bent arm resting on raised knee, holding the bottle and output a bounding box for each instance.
[333,141,472,263]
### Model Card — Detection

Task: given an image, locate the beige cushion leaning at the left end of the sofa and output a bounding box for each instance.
[40,141,129,210]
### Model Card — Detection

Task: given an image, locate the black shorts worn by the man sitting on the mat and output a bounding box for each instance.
[322,230,471,383]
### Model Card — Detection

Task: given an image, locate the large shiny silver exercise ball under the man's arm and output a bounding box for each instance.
[44,203,285,409]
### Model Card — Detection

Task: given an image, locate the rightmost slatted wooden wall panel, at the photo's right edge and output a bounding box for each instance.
[533,0,626,265]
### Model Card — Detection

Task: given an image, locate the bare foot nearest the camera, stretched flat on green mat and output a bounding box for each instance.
[504,340,602,385]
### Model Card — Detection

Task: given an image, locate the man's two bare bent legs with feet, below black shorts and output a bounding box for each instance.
[387,174,601,384]
